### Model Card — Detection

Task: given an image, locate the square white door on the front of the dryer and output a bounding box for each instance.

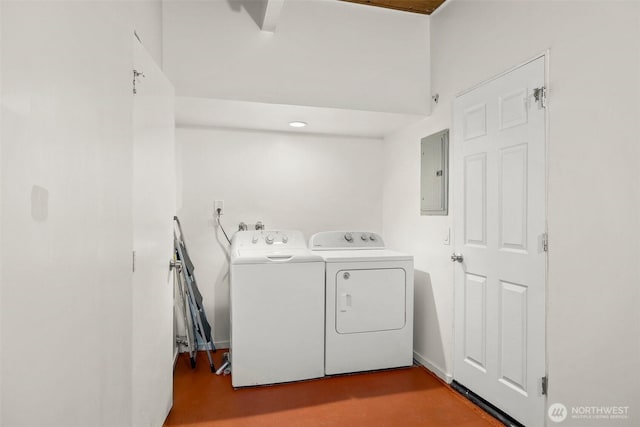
[335,268,406,334]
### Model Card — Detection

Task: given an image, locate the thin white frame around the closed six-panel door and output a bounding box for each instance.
[449,49,551,425]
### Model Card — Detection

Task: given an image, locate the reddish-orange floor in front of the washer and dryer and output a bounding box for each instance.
[165,350,502,427]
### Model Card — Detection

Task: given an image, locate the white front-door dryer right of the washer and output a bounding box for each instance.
[309,231,413,375]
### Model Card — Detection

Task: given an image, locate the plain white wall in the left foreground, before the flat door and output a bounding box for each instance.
[0,1,159,427]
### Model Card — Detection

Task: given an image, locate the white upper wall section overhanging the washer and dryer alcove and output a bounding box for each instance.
[163,0,430,113]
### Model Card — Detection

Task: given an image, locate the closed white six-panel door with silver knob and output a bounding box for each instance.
[452,57,546,426]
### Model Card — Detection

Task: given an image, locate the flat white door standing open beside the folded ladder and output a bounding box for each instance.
[131,38,176,426]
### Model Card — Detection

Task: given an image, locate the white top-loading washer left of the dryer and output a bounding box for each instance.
[230,230,324,387]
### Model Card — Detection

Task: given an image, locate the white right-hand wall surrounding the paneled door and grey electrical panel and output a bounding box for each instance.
[383,0,640,426]
